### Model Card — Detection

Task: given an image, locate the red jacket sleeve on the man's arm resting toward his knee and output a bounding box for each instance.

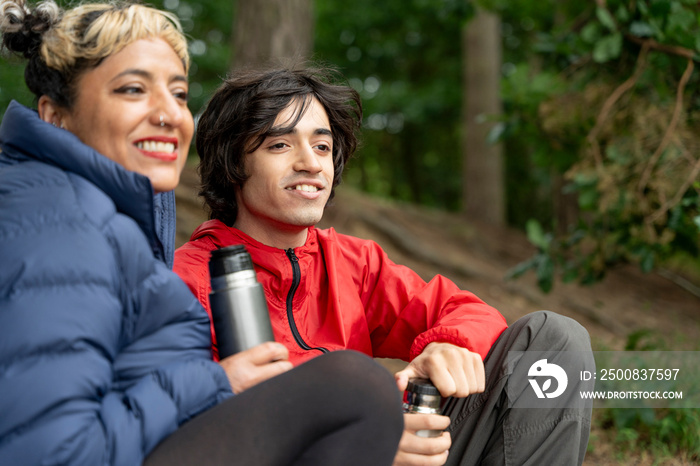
[358,241,507,360]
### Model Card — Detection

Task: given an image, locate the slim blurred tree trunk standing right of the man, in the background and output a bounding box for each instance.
[462,10,505,225]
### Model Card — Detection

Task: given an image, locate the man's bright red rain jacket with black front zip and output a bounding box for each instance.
[174,220,506,365]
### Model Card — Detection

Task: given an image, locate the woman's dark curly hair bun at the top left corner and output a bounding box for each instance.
[0,0,61,58]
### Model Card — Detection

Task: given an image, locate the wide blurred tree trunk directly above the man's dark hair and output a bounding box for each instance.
[231,0,314,68]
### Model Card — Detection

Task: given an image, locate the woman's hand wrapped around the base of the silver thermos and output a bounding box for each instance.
[219,342,293,393]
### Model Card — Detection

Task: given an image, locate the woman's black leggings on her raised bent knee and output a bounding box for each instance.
[144,351,403,466]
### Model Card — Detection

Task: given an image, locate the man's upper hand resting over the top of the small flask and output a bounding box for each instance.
[394,342,485,398]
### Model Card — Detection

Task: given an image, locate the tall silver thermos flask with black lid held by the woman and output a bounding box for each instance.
[209,244,275,359]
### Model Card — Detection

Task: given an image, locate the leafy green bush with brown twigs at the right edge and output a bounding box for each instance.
[503,0,700,291]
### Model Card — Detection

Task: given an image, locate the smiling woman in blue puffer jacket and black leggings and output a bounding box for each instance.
[0,0,402,465]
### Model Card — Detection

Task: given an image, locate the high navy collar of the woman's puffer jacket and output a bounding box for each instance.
[0,100,175,266]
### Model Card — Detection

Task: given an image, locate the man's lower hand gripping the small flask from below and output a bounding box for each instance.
[393,413,452,466]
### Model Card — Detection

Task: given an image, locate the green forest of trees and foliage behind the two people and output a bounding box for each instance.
[0,0,700,461]
